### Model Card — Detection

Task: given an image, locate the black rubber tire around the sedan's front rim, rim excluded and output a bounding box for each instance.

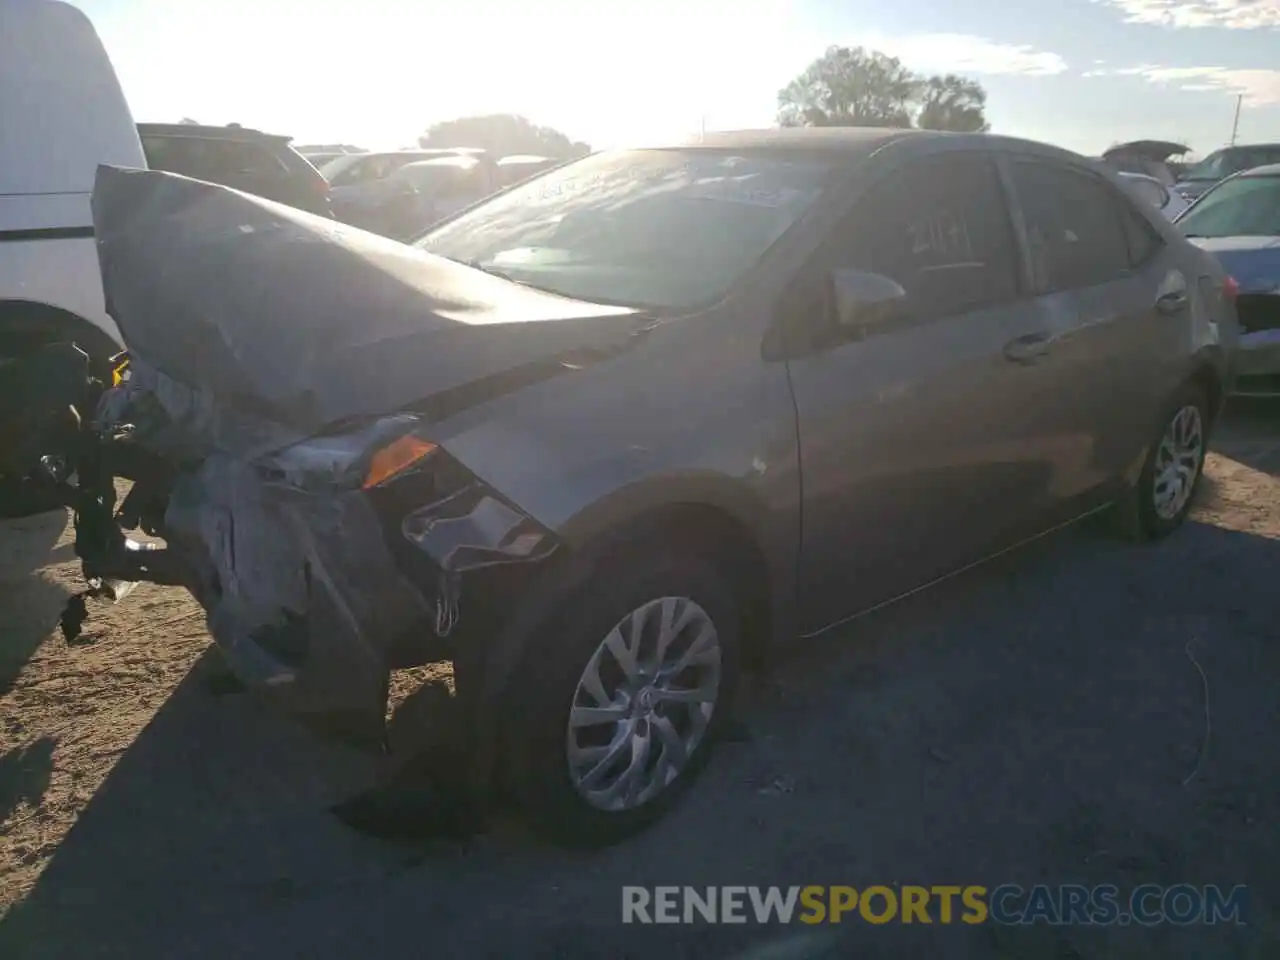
[503,541,742,847]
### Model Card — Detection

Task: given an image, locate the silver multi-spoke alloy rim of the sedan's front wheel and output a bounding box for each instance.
[566,596,721,812]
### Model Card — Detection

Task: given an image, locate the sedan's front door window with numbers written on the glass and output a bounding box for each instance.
[829,154,1018,320]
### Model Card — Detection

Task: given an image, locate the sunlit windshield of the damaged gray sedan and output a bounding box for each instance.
[417,150,832,310]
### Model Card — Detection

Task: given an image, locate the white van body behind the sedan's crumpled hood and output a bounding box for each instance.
[0,0,146,361]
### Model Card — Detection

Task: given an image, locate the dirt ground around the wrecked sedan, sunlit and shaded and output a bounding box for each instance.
[0,406,1280,960]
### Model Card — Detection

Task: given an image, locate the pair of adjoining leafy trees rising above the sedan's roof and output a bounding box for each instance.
[778,46,988,132]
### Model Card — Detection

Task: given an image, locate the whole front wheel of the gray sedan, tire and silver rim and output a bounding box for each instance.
[506,547,741,846]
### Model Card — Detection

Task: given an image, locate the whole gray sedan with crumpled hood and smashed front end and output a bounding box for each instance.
[9,131,1235,842]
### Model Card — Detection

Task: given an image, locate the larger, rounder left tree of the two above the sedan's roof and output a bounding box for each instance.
[778,46,919,127]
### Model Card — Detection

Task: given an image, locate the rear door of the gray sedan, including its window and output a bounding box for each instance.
[1006,156,1172,518]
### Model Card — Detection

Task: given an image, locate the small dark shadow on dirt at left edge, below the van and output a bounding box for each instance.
[0,509,74,696]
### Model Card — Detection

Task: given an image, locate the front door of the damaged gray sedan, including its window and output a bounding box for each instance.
[787,151,1056,630]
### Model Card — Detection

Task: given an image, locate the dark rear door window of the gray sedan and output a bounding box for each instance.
[1012,160,1131,292]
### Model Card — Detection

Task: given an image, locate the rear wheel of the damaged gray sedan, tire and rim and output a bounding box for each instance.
[1111,384,1210,540]
